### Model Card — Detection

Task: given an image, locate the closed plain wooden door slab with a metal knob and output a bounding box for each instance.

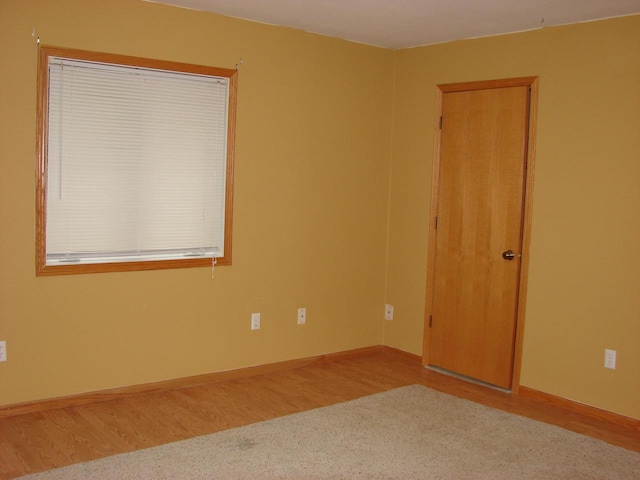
[428,85,530,388]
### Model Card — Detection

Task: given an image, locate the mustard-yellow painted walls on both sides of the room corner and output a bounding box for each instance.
[0,0,640,418]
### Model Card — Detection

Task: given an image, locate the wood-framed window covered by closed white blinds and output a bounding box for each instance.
[36,46,237,275]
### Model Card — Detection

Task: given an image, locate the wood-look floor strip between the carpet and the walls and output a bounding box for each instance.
[0,349,640,480]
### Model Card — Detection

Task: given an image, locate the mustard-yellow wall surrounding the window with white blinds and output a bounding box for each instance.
[0,0,393,405]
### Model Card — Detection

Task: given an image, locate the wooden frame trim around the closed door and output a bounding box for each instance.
[422,77,538,393]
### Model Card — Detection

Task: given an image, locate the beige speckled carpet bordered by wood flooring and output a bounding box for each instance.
[16,385,640,480]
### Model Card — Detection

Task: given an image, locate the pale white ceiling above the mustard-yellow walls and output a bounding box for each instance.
[146,0,640,49]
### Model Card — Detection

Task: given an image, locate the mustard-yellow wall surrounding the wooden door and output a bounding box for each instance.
[385,16,640,418]
